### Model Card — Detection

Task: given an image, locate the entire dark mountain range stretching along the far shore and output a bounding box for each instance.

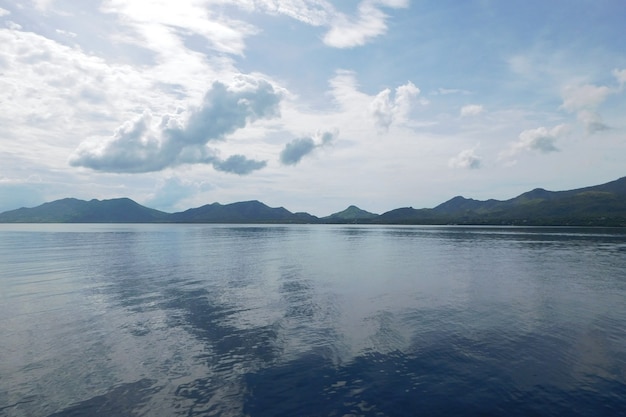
[0,177,626,227]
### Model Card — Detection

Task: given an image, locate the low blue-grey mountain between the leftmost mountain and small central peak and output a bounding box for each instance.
[168,200,318,223]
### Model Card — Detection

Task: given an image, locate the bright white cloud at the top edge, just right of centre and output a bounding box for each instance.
[323,0,408,48]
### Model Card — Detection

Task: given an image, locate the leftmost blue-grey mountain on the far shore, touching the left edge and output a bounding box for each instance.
[0,198,169,223]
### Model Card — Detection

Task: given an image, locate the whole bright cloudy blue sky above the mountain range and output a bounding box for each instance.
[0,0,626,216]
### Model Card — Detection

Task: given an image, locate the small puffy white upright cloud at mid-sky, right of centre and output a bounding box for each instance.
[369,81,426,132]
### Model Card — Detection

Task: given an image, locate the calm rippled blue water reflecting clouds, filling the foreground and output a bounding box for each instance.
[0,225,626,417]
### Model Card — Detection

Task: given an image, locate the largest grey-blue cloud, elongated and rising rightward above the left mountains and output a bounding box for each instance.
[69,75,281,175]
